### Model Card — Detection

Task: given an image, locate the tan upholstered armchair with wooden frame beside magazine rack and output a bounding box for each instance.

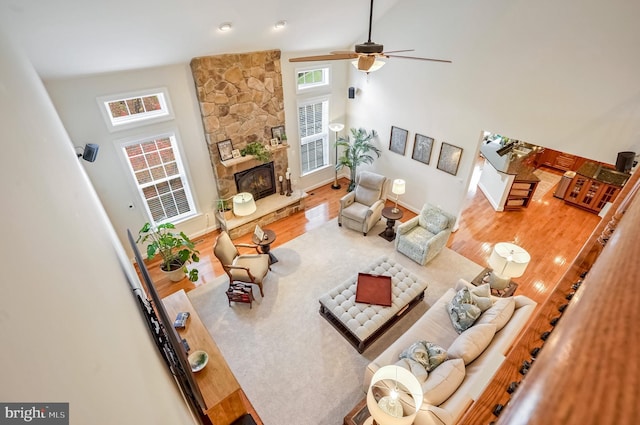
[213,232,270,296]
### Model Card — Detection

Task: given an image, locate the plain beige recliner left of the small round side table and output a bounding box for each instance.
[338,171,387,236]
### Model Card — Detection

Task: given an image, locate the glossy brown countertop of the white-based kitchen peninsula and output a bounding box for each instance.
[480,141,540,182]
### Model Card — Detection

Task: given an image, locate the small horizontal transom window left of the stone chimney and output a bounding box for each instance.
[98,89,173,131]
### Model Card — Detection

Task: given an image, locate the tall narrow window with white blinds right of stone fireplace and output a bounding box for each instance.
[298,98,329,175]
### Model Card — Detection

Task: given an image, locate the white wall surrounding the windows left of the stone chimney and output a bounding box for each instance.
[45,64,217,256]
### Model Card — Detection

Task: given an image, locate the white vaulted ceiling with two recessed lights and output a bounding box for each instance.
[0,0,401,79]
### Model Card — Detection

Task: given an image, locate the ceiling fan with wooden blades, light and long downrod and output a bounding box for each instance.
[289,0,451,73]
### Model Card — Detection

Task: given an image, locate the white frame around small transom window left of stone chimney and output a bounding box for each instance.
[96,87,174,132]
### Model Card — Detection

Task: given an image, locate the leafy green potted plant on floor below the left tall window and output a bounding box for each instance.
[136,223,200,282]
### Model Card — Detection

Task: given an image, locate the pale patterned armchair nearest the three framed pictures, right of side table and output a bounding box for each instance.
[396,204,456,266]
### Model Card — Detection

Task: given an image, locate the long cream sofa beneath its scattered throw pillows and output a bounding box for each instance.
[363,279,536,425]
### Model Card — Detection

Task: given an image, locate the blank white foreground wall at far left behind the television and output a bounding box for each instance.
[0,29,195,425]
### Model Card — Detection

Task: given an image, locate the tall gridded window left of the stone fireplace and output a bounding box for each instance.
[122,133,196,224]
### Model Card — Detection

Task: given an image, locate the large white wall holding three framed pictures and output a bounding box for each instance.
[349,0,640,215]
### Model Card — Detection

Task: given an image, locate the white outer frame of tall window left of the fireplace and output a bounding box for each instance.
[116,130,198,225]
